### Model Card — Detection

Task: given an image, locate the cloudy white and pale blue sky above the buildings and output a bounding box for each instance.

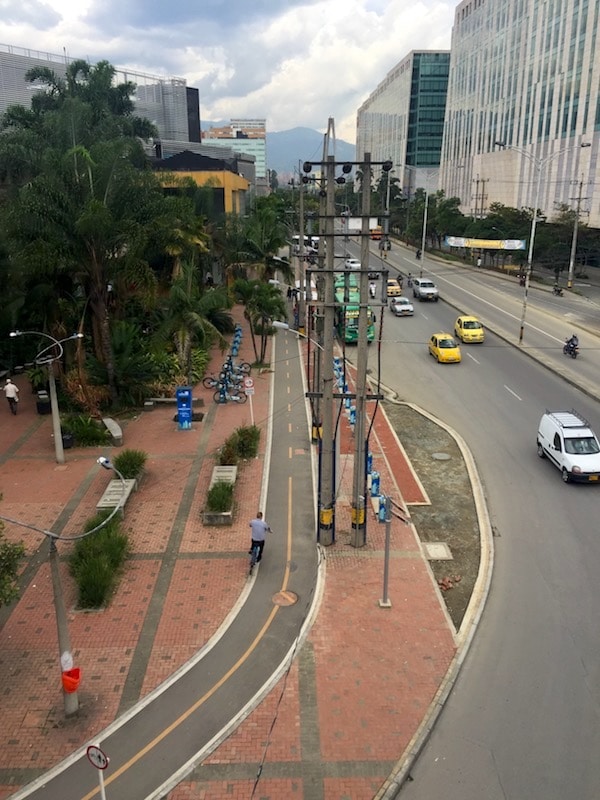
[0,0,458,143]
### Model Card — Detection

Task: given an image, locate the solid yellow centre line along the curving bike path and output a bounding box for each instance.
[81,476,292,800]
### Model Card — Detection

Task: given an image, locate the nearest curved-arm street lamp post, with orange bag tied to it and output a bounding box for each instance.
[0,456,126,717]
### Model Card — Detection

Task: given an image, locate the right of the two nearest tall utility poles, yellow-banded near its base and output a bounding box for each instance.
[350,153,372,547]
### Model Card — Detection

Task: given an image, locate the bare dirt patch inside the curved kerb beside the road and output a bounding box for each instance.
[383,400,480,629]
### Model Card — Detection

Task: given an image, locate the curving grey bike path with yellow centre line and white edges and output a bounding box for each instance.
[10,337,318,800]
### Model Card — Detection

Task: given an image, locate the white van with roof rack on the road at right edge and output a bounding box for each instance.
[537,411,600,483]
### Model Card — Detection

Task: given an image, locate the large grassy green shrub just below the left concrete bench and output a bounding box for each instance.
[69,511,129,608]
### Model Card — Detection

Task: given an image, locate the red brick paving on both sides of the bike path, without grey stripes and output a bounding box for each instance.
[0,309,455,800]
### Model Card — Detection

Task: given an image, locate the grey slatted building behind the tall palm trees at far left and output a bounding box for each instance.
[0,44,192,141]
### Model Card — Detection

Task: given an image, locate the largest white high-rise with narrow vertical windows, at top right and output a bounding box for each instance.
[440,0,600,226]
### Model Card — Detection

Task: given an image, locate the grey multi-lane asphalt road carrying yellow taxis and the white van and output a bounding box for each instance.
[342,242,600,800]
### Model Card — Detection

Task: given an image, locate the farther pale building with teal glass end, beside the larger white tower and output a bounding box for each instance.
[356,50,450,192]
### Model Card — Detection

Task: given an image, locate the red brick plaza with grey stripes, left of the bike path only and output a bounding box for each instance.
[0,308,270,798]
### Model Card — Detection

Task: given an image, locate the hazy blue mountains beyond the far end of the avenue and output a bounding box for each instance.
[201,121,356,184]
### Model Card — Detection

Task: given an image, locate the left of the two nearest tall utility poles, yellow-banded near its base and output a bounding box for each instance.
[319,156,338,547]
